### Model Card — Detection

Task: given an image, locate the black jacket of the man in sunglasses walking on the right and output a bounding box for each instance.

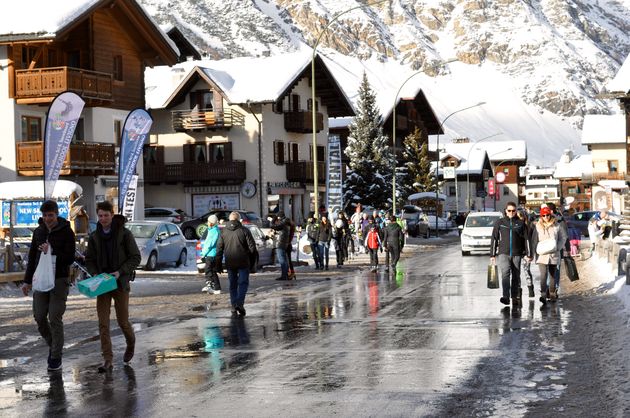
[490,216,529,257]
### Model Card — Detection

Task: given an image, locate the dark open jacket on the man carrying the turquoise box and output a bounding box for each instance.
[85,215,142,290]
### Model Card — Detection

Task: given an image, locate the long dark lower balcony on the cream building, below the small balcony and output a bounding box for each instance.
[144,160,247,184]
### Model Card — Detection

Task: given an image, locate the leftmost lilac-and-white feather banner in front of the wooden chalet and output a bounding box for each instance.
[44,91,85,200]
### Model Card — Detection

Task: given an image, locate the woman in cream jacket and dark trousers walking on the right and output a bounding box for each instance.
[530,207,567,304]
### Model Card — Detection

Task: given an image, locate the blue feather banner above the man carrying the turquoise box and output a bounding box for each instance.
[118,109,153,219]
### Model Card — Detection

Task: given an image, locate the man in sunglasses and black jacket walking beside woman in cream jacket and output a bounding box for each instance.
[490,202,531,309]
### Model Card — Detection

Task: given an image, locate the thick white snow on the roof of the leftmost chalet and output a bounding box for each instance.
[0,0,179,55]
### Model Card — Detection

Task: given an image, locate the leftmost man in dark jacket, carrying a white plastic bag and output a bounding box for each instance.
[22,200,75,371]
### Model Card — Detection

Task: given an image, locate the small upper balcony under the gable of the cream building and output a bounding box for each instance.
[171,109,245,132]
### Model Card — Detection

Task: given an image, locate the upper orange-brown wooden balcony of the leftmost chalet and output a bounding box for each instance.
[15,67,112,104]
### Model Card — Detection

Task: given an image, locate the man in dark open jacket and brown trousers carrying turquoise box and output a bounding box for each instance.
[85,201,141,373]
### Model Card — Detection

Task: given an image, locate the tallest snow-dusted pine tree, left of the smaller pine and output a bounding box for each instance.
[344,73,395,209]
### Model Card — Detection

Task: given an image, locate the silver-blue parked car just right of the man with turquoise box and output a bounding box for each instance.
[125,221,188,270]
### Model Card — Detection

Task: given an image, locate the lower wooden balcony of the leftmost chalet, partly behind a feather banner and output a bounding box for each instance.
[16,141,116,176]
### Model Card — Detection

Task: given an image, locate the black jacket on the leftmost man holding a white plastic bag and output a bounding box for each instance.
[24,217,75,284]
